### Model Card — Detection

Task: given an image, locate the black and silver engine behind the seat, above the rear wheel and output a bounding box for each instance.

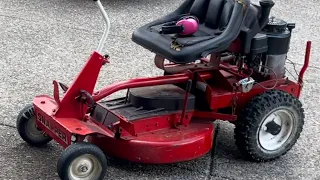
[247,17,295,79]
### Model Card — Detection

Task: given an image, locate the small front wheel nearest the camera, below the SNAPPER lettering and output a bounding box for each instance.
[57,142,107,180]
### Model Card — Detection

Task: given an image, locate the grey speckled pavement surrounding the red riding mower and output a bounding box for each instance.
[0,0,320,180]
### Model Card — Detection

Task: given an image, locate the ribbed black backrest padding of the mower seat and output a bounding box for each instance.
[189,0,234,30]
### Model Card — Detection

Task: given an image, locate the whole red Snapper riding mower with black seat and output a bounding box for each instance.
[17,0,311,179]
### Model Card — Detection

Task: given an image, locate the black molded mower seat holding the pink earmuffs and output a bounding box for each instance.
[132,0,250,64]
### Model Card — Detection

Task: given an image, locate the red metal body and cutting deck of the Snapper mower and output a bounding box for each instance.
[33,42,311,163]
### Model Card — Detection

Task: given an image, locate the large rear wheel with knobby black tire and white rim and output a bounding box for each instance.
[235,90,304,162]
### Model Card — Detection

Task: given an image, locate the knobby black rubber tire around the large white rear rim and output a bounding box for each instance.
[234,90,305,162]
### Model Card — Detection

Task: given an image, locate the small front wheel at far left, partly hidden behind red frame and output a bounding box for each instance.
[16,105,52,146]
